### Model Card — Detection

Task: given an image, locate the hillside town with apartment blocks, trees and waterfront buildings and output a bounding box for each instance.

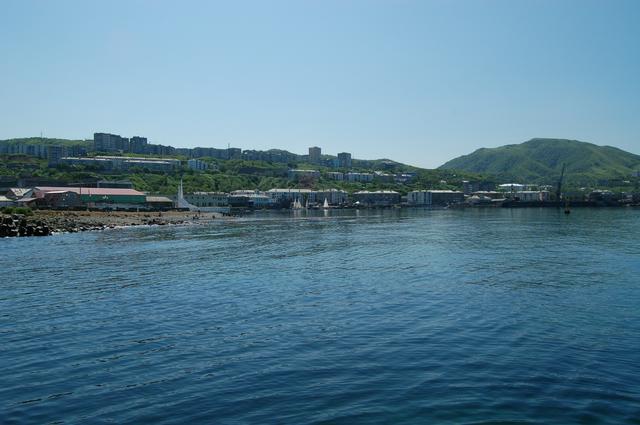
[0,133,639,214]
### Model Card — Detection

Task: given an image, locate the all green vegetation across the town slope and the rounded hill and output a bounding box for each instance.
[0,137,640,194]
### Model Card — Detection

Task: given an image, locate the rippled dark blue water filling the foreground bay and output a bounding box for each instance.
[0,209,640,424]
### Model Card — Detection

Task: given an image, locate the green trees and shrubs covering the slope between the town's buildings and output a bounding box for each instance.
[0,150,480,195]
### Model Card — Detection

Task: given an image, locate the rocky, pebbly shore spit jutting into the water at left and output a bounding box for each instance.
[0,210,221,237]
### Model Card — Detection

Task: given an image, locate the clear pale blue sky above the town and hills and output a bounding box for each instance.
[0,0,640,167]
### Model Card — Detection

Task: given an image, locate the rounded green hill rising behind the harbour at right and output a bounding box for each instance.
[439,138,640,182]
